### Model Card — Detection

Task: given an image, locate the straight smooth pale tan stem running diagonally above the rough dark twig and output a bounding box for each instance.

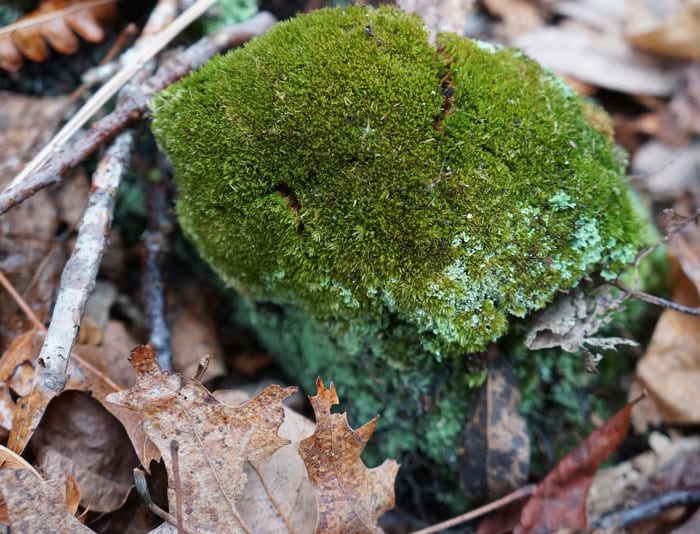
[8,0,216,197]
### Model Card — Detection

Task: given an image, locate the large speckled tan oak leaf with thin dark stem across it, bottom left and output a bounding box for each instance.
[108,346,295,532]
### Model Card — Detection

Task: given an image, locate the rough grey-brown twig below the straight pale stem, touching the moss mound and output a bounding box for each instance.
[0,11,276,215]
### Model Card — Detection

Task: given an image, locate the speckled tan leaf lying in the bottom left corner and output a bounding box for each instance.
[0,468,87,534]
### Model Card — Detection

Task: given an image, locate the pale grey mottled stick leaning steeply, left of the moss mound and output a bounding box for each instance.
[33,131,134,394]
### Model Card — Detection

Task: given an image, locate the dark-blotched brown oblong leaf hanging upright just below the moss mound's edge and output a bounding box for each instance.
[460,351,530,500]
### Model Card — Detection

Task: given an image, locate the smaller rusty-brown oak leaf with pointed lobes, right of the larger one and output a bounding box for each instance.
[299,378,399,533]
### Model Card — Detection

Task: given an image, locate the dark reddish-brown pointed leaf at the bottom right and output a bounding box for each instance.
[520,401,636,533]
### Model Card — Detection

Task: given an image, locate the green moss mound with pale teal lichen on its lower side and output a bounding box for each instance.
[151,7,645,472]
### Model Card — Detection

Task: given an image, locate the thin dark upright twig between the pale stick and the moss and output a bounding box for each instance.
[142,172,174,371]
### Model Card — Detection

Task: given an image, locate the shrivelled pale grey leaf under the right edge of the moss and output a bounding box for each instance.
[525,286,637,358]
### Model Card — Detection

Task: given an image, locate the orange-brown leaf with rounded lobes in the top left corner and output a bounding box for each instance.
[0,0,115,72]
